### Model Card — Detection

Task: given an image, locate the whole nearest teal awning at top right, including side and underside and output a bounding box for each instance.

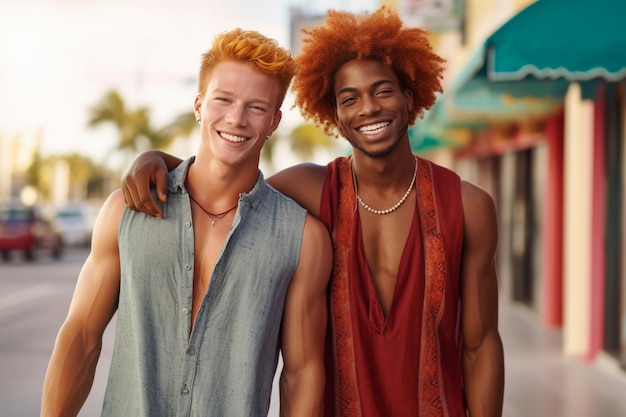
[449,0,626,98]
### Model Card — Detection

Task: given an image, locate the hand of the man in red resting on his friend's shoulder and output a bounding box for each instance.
[122,150,182,218]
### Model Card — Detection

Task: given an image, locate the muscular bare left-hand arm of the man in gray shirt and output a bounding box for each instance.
[41,191,124,417]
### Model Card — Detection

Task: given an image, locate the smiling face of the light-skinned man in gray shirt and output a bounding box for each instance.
[194,61,281,165]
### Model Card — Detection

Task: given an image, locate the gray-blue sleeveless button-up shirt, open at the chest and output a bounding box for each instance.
[102,158,306,417]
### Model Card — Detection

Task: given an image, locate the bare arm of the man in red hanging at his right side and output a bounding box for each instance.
[461,182,504,417]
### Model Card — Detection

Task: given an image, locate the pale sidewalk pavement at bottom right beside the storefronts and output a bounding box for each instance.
[500,302,626,417]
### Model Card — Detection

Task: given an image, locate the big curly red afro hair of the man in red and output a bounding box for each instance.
[292,6,445,135]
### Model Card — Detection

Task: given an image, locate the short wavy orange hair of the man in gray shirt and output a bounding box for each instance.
[198,28,296,110]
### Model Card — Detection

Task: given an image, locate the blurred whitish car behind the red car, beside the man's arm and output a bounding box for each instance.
[54,205,94,246]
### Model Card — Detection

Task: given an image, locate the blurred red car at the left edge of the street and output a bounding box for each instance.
[0,203,64,261]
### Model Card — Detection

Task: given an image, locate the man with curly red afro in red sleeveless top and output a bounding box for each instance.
[124,7,504,417]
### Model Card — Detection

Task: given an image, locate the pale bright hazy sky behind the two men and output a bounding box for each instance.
[0,0,379,169]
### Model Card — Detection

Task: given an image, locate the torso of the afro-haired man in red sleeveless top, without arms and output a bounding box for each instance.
[319,158,464,417]
